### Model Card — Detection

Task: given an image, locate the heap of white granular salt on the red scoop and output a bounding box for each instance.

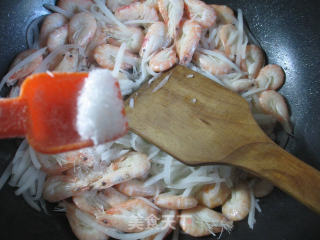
[76,69,127,145]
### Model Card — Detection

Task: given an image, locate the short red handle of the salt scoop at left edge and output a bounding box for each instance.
[0,98,27,138]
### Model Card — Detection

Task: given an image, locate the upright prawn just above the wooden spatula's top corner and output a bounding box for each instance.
[176,20,201,65]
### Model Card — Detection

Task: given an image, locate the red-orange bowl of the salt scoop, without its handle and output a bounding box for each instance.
[21,73,92,152]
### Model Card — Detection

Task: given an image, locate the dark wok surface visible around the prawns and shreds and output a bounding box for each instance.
[0,0,320,240]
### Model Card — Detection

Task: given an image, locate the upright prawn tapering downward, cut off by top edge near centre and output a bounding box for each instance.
[158,0,184,39]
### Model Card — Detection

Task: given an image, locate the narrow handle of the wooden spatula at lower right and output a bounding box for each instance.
[223,143,320,213]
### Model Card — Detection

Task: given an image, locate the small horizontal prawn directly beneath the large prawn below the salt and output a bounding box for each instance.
[115,179,161,197]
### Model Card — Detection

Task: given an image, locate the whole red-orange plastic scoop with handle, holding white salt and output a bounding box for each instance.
[0,73,127,153]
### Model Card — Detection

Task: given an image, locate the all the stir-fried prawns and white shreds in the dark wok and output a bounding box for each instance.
[0,0,291,240]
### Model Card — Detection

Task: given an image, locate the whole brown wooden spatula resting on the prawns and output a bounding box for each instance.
[126,66,320,213]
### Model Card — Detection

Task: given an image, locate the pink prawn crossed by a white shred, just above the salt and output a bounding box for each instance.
[93,44,139,70]
